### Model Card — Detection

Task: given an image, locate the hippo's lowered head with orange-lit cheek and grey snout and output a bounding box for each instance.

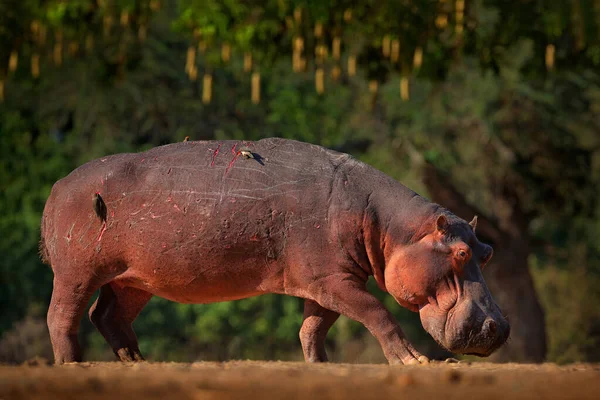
[384,214,510,357]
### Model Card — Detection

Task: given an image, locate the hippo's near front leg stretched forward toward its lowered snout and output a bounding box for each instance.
[311,275,429,365]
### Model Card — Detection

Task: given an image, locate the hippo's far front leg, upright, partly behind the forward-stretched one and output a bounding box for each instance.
[300,299,340,362]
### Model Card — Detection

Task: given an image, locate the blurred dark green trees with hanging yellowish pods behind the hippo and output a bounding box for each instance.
[0,0,600,363]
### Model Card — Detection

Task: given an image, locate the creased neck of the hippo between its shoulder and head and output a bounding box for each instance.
[356,169,448,291]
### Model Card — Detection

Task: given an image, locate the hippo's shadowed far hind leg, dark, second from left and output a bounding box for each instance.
[89,282,152,362]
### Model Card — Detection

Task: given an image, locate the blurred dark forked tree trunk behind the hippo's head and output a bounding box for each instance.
[423,163,546,362]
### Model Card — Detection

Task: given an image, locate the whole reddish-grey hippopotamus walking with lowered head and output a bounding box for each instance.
[40,138,510,364]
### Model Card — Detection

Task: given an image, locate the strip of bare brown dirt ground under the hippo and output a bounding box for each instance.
[0,361,600,400]
